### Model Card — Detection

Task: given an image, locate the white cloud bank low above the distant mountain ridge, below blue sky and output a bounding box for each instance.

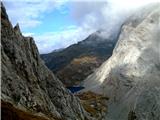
[34,26,94,54]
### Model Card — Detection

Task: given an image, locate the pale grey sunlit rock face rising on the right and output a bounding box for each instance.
[84,4,160,120]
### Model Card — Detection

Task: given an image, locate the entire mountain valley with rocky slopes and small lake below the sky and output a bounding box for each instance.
[1,2,160,120]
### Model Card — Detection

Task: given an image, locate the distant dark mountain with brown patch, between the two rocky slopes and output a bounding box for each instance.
[41,30,119,86]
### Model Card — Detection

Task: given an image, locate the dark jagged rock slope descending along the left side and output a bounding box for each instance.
[1,3,91,120]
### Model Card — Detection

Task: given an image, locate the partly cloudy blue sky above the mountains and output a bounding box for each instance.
[2,0,160,54]
